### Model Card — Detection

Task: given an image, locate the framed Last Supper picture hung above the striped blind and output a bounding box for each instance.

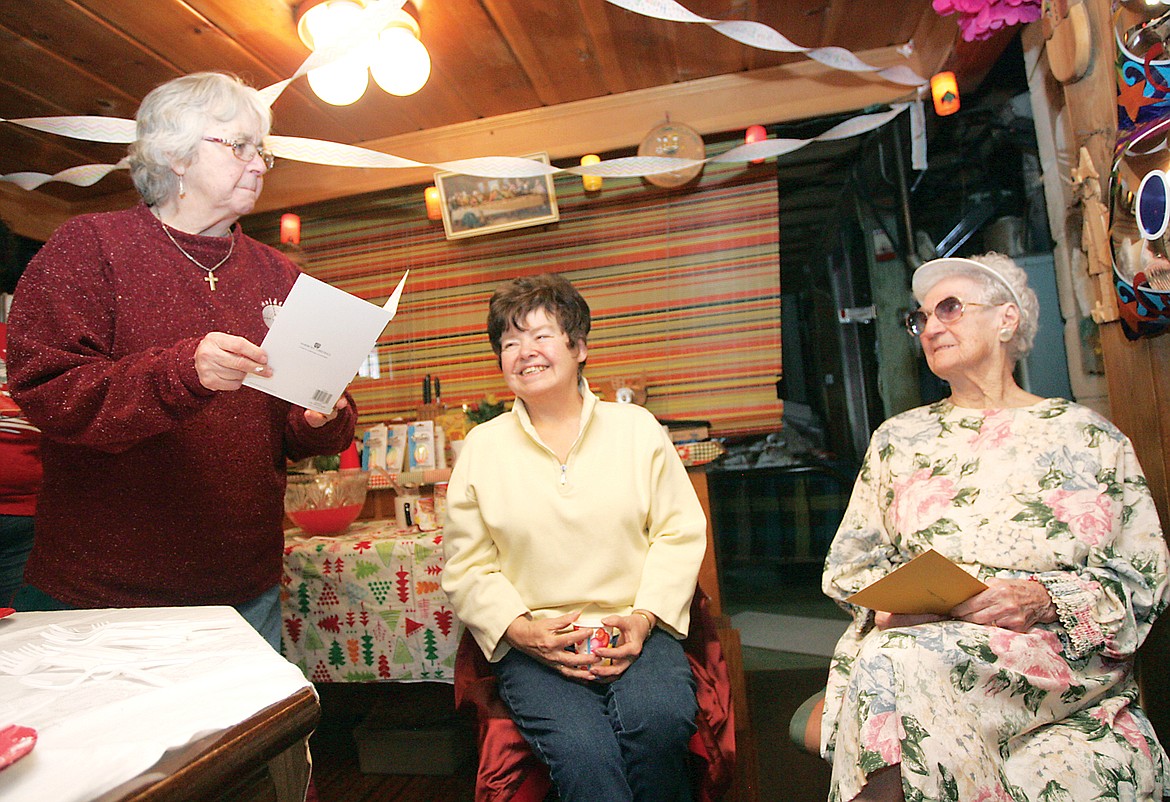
[435,152,560,240]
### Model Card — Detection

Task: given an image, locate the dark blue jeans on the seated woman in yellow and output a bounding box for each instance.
[494,630,698,802]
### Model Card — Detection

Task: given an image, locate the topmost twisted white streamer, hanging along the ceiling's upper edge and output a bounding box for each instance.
[606,0,927,87]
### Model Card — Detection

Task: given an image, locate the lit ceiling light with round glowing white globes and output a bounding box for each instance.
[296,0,431,105]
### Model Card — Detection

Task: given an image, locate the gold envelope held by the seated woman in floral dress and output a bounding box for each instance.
[845,549,987,616]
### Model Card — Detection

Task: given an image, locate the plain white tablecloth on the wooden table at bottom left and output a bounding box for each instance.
[0,606,311,802]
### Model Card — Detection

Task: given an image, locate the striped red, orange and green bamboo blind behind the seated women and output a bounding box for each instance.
[248,140,782,436]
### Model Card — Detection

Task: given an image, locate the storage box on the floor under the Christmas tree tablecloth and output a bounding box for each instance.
[353,713,475,774]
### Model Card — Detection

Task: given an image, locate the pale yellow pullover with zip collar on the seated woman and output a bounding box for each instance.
[442,385,707,662]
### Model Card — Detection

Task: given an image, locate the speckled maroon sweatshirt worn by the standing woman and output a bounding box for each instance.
[8,205,357,608]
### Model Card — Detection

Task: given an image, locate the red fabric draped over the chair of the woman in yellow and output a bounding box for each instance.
[455,591,735,802]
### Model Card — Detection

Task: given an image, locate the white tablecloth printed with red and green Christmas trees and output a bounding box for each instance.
[281,520,462,683]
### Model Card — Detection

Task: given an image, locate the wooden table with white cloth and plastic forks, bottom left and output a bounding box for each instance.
[0,606,321,802]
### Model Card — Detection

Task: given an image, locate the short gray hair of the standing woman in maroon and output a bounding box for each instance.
[130,73,273,206]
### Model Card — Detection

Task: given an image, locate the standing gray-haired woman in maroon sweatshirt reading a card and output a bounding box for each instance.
[8,73,356,646]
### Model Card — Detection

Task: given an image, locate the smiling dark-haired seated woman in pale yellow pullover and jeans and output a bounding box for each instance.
[442,275,707,802]
